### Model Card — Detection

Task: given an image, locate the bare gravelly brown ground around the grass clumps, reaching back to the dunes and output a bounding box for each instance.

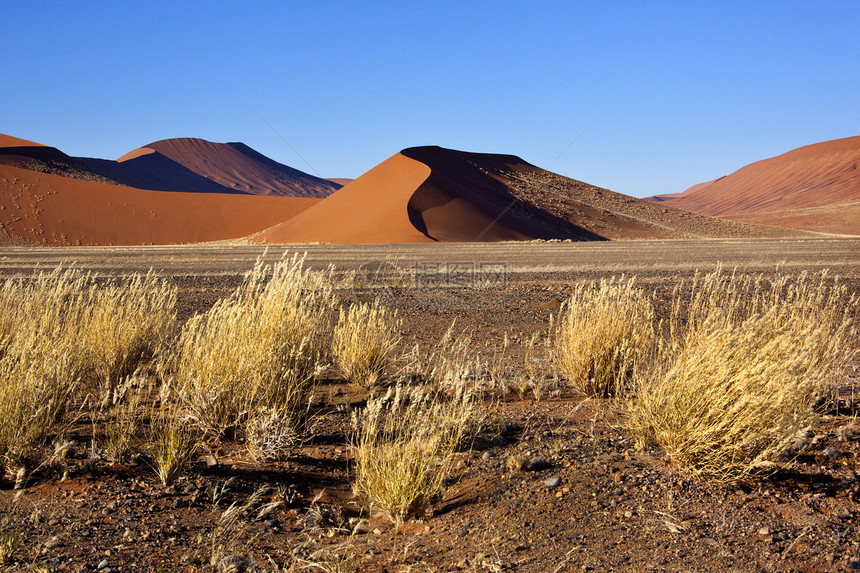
[0,240,860,572]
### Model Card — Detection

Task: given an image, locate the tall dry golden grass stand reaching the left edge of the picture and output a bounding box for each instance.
[0,268,176,469]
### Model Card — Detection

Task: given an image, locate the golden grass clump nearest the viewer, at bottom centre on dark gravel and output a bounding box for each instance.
[352,385,480,521]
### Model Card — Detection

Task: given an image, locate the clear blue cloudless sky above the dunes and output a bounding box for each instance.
[0,0,860,196]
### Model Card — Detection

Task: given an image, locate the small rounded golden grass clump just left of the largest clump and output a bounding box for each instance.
[550,278,654,398]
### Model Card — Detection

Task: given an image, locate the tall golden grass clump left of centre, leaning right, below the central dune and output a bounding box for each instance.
[170,256,333,436]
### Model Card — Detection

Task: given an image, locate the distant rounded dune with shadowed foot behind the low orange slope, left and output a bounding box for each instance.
[85,137,341,198]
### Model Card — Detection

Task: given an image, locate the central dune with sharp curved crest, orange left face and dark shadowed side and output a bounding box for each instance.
[254,146,797,243]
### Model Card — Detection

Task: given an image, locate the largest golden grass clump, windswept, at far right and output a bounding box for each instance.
[627,270,858,481]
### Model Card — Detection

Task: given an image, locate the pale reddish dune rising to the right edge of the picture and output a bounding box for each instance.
[649,136,860,235]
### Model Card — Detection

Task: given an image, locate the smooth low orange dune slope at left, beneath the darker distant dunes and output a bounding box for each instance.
[0,165,318,245]
